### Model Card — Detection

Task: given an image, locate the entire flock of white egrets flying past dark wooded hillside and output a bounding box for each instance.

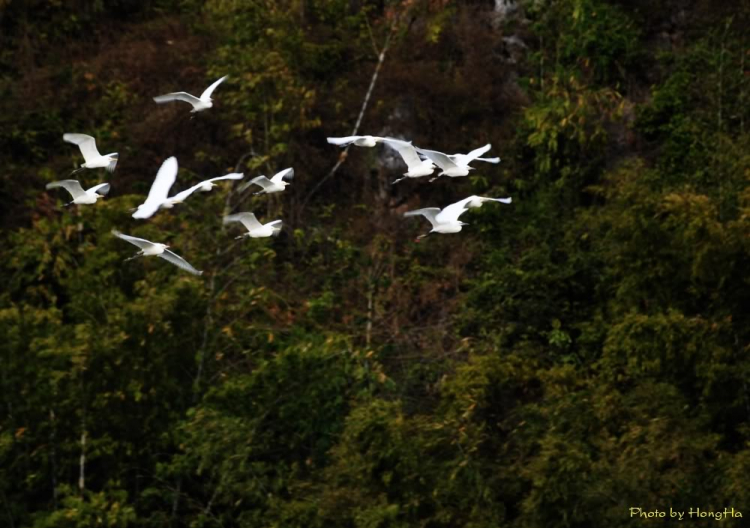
[47,76,511,275]
